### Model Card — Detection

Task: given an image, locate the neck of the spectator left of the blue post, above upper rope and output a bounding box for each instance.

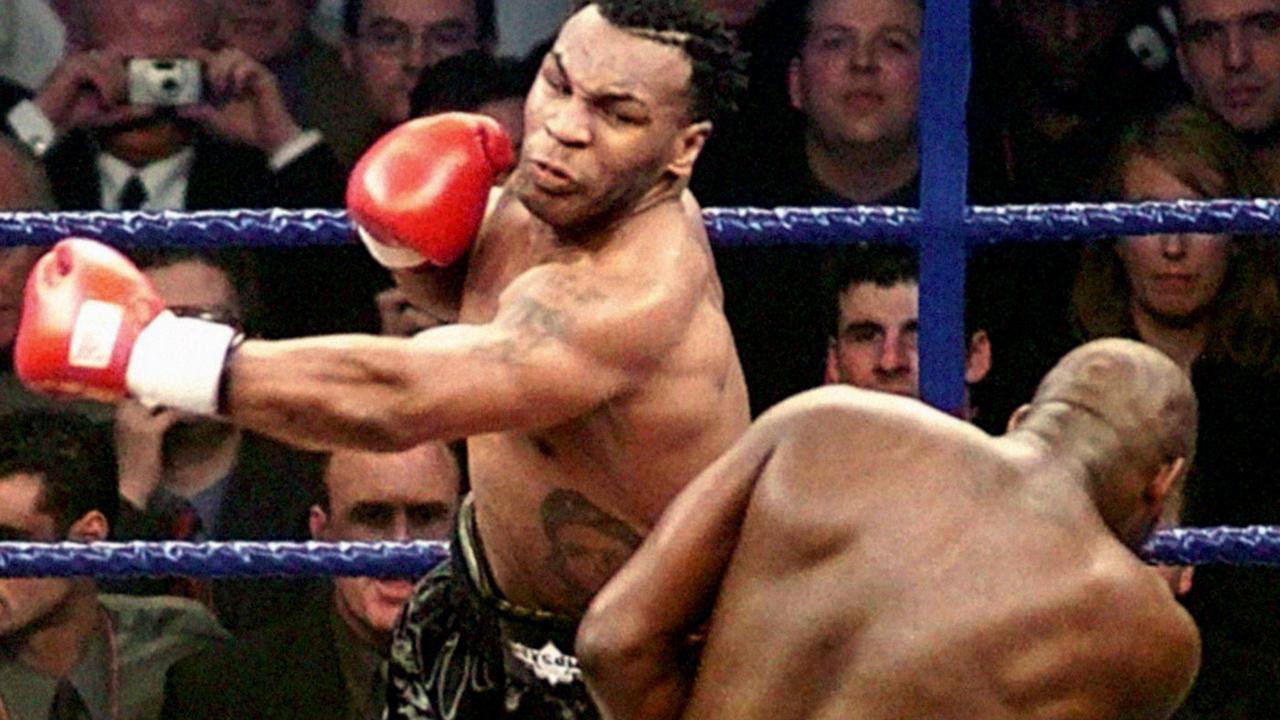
[805,131,920,202]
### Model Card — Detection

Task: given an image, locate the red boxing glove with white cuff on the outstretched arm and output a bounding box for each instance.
[13,238,236,414]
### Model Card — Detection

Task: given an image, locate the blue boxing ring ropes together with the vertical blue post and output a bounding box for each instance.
[0,0,1280,578]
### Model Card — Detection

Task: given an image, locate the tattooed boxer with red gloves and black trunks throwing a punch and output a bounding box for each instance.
[15,0,749,719]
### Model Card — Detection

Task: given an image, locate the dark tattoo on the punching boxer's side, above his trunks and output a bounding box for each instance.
[540,488,644,607]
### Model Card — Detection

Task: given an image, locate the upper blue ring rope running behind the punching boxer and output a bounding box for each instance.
[0,199,1280,247]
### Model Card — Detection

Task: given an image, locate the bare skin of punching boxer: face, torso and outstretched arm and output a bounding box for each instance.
[217,5,749,615]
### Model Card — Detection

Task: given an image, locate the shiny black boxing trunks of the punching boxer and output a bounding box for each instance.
[387,497,599,720]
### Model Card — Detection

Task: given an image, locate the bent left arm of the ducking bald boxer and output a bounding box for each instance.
[576,415,776,720]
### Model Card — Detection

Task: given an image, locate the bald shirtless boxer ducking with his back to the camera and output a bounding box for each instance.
[577,340,1199,720]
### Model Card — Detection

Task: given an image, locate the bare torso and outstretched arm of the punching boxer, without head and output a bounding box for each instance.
[229,184,749,612]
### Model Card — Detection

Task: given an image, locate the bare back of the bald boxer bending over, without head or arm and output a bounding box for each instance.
[685,388,1198,720]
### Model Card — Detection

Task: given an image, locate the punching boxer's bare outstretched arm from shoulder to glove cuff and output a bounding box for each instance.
[223,257,687,450]
